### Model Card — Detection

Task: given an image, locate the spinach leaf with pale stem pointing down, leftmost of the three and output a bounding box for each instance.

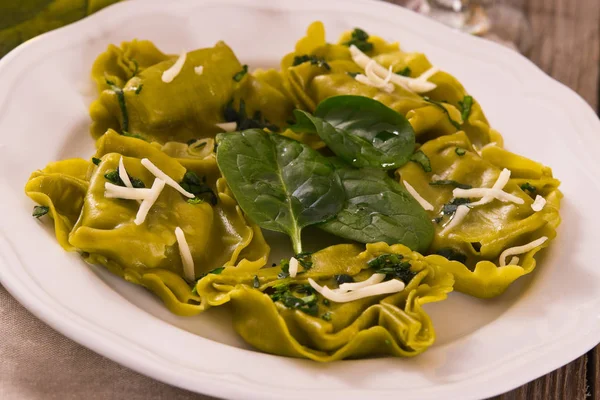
[217,129,345,254]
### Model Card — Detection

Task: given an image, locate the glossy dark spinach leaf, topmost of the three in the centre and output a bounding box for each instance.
[291,96,415,170]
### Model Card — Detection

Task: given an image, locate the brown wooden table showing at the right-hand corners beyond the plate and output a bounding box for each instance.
[388,0,600,400]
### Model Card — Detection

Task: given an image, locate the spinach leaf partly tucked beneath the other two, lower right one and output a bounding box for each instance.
[319,167,434,251]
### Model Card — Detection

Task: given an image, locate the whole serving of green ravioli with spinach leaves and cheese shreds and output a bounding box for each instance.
[25,22,562,362]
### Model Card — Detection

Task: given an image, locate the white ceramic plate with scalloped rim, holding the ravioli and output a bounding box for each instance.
[0,0,600,400]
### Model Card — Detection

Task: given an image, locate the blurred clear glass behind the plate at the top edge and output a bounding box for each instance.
[394,0,532,53]
